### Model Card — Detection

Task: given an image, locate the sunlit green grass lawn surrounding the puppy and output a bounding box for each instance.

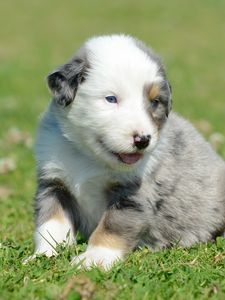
[0,0,225,300]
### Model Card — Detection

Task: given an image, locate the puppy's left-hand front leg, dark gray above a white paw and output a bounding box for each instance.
[25,180,75,260]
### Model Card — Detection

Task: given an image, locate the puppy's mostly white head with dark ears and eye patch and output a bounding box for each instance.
[48,35,171,169]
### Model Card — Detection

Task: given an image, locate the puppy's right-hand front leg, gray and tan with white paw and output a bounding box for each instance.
[72,205,144,270]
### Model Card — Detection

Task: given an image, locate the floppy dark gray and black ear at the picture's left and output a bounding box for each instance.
[47,56,87,107]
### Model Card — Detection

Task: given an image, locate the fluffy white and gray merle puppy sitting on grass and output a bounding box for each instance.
[31,35,225,269]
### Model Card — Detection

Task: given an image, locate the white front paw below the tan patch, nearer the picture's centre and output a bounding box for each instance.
[71,245,123,271]
